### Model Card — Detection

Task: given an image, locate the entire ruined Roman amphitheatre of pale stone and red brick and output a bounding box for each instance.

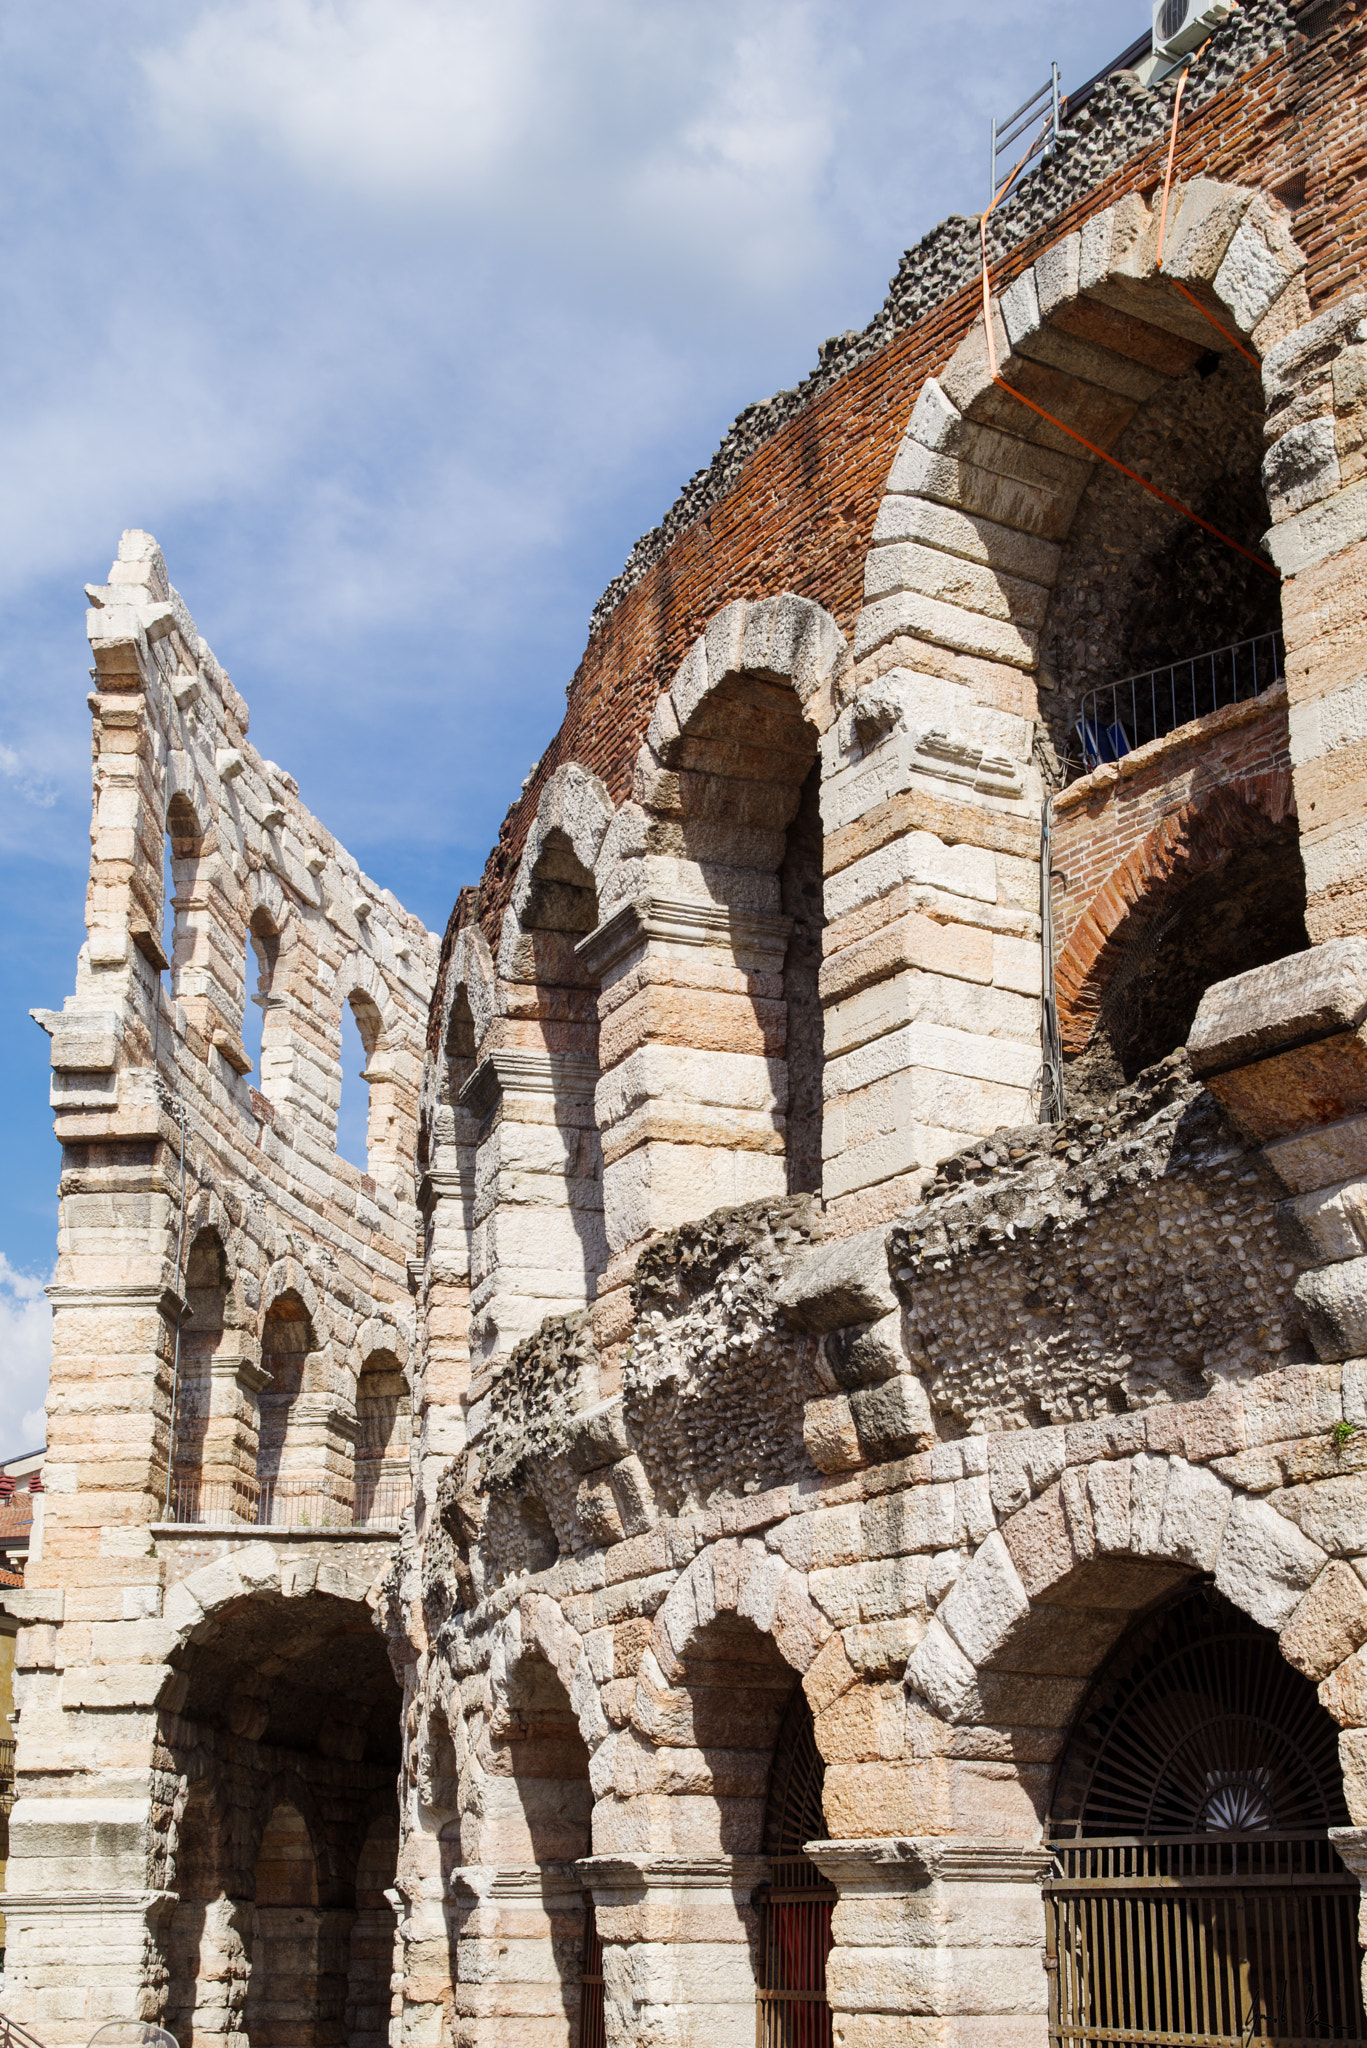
[0,0,1367,2048]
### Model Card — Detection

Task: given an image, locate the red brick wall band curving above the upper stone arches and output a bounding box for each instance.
[437,0,1367,1048]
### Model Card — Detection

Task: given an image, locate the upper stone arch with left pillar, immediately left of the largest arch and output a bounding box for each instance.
[578,594,848,1255]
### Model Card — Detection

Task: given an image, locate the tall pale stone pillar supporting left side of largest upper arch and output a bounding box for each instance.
[820,651,1041,1223]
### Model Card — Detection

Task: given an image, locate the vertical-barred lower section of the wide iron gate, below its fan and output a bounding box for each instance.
[1045,1833,1367,2048]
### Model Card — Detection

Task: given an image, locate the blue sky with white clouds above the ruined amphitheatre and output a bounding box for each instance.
[0,0,1148,1452]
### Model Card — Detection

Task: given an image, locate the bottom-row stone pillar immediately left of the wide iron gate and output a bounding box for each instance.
[807,1835,1053,2048]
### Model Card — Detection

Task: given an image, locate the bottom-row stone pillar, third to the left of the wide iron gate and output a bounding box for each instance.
[449,1864,584,2048]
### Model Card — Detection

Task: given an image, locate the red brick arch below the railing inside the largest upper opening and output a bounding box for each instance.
[1055,768,1295,1077]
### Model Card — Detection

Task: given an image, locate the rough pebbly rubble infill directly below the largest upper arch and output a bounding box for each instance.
[889,1053,1312,1427]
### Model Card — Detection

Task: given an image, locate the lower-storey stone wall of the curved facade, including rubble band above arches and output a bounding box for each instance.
[387,1024,1367,2042]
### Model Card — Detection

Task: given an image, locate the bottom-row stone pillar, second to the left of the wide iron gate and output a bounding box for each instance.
[576,1855,769,2048]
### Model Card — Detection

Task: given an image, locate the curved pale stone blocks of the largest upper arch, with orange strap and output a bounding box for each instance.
[855,178,1310,692]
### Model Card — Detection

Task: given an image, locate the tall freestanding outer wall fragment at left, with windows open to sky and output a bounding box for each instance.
[6,532,437,2040]
